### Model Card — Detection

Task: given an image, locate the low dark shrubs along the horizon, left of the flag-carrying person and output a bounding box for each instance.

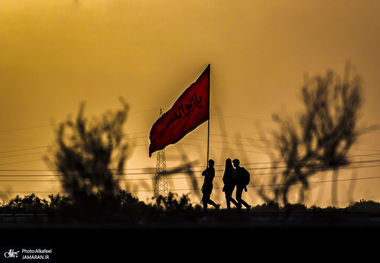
[0,193,202,224]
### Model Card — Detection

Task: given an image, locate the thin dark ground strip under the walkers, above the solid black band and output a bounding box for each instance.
[0,210,380,230]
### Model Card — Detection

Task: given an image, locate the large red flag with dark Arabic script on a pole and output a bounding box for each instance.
[149,65,210,157]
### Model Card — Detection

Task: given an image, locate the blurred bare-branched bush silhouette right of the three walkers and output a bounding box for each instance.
[258,63,374,206]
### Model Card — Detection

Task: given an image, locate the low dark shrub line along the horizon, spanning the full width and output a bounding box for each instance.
[0,193,380,227]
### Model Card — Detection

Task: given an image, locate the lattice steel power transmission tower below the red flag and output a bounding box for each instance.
[154,109,168,197]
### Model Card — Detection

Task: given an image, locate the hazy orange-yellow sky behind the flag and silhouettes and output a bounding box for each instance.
[0,0,380,206]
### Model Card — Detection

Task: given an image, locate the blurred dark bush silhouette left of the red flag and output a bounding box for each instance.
[46,98,129,220]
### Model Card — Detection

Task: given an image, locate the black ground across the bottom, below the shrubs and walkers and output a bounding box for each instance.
[0,213,380,262]
